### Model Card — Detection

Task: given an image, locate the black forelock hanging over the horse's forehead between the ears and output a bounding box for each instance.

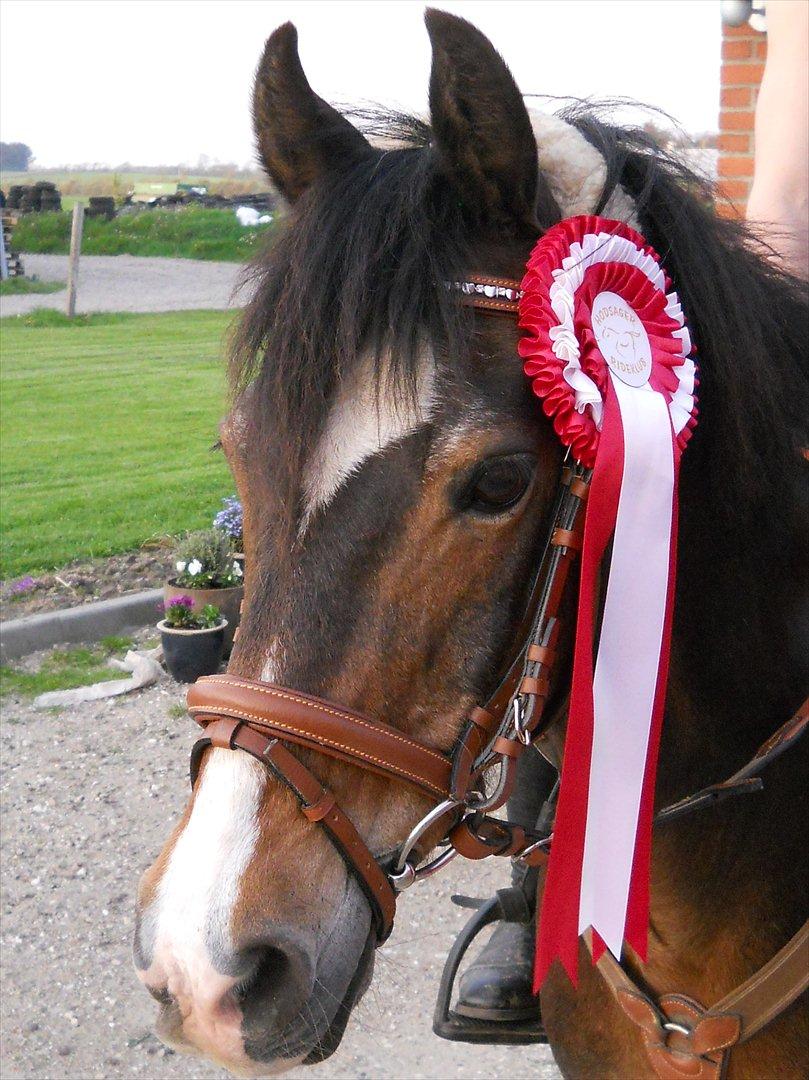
[230,116,470,537]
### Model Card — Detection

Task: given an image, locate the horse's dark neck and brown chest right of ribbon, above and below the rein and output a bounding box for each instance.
[650,451,809,986]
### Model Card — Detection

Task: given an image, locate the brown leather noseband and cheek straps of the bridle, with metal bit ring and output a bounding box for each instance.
[188,427,590,944]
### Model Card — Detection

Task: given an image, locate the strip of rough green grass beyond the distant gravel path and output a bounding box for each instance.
[14,206,272,262]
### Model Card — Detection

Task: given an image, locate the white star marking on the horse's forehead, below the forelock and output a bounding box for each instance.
[300,359,435,534]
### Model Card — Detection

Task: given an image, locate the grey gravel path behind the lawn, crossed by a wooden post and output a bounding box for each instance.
[0,255,242,316]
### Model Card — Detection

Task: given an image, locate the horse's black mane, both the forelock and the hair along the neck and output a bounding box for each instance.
[230,105,809,552]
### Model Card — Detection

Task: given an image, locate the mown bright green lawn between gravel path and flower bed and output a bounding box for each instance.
[0,311,233,578]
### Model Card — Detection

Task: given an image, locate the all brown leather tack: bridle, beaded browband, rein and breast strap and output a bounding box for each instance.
[188,275,809,1077]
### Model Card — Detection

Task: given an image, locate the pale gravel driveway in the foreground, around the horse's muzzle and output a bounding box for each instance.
[0,652,558,1080]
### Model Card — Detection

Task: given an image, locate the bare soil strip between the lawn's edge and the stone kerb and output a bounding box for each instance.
[0,543,174,619]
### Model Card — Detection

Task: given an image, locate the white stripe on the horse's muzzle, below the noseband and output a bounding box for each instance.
[141,748,266,1040]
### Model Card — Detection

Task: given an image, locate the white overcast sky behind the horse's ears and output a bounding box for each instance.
[0,0,720,166]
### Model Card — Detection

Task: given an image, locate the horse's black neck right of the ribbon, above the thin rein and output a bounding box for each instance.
[661,451,809,788]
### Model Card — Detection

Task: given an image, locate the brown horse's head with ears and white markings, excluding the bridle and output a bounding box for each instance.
[136,12,574,1072]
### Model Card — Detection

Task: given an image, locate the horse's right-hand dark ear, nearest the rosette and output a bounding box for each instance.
[424,8,539,235]
